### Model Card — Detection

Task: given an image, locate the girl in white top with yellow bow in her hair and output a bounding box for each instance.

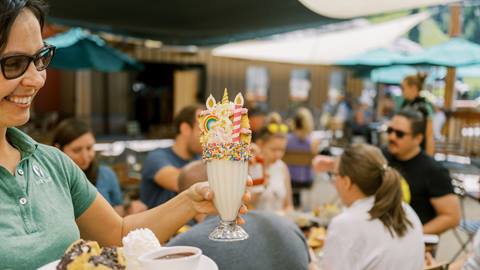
[252,117,293,211]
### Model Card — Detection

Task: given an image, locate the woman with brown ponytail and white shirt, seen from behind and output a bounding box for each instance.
[323,144,424,270]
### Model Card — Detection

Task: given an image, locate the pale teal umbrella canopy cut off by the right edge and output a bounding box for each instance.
[396,38,480,67]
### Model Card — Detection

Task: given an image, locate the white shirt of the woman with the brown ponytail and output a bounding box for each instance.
[323,196,425,270]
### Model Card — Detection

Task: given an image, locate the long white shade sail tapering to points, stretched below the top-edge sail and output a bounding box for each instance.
[212,12,429,65]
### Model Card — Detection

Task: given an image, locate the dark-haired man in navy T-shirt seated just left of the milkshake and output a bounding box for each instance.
[140,105,202,208]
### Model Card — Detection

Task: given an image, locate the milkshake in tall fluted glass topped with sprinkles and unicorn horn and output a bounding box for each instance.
[198,89,251,241]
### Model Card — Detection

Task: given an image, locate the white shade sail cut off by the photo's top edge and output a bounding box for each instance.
[299,0,460,19]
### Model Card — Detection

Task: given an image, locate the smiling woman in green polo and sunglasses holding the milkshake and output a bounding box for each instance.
[0,0,248,269]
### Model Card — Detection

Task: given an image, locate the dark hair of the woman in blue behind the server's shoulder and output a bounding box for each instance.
[51,118,99,185]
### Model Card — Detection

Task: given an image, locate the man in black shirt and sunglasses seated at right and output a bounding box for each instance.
[383,110,460,234]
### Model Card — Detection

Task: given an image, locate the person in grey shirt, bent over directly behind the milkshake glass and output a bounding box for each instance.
[167,161,315,270]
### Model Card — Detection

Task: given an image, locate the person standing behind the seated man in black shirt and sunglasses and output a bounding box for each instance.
[401,73,435,156]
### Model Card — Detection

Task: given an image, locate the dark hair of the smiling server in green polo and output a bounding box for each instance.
[0,0,47,52]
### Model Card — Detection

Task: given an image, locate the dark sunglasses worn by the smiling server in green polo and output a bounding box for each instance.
[0,44,55,80]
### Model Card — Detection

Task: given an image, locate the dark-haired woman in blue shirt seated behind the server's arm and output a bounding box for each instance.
[52,118,146,216]
